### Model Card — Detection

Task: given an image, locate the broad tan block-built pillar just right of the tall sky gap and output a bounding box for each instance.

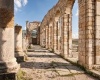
[78,0,95,69]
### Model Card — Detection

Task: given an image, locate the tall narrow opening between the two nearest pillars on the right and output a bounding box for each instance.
[72,0,79,60]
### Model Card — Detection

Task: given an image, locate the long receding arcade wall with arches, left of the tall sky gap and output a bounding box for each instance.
[40,0,75,57]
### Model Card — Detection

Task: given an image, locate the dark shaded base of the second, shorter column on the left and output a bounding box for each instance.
[15,52,27,63]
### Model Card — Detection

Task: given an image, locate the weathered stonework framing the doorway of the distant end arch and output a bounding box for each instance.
[26,21,41,46]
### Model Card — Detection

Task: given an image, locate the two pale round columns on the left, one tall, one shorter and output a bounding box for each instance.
[0,0,25,73]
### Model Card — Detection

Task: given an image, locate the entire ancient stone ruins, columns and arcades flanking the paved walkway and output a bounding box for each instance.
[0,0,100,79]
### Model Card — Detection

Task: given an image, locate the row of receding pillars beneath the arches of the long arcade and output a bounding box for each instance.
[41,13,72,58]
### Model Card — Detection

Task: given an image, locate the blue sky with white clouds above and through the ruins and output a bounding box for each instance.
[14,0,78,37]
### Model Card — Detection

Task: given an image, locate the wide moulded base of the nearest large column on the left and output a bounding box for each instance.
[0,58,20,73]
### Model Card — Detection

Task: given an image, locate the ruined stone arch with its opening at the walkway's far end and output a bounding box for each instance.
[26,21,41,46]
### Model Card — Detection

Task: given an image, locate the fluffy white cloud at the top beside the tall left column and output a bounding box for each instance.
[14,0,28,11]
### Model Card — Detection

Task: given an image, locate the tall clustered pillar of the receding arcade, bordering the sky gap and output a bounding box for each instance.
[61,13,72,59]
